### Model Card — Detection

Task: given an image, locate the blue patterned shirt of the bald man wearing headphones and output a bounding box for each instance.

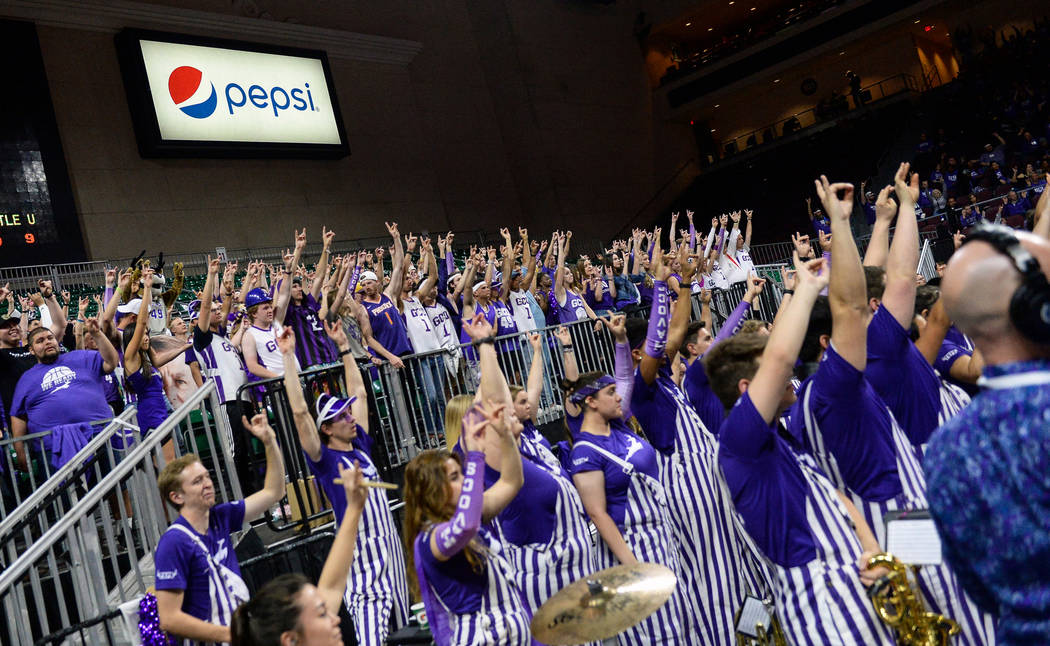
[924,360,1050,645]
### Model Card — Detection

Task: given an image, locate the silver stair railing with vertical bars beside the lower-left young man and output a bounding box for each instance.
[0,383,242,644]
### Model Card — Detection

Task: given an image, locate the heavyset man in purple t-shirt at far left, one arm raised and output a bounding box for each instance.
[11,318,120,468]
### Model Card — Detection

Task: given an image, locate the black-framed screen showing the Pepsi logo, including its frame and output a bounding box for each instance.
[117,29,350,158]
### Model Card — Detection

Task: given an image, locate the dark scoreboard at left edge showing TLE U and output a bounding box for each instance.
[0,20,84,267]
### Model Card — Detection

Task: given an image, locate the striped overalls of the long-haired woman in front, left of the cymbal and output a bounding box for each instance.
[415,527,537,646]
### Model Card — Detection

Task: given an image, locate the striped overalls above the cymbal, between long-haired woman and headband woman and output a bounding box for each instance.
[494,457,595,613]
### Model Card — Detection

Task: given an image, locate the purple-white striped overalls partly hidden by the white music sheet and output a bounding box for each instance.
[800,383,995,646]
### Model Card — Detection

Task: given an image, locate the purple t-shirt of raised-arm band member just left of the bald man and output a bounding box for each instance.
[864,307,941,446]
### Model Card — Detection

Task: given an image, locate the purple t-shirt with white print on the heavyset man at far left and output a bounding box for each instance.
[11,350,113,433]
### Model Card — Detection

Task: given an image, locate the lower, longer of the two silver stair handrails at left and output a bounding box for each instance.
[0,381,215,595]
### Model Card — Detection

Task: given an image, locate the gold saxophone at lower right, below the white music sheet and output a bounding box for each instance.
[867,553,960,646]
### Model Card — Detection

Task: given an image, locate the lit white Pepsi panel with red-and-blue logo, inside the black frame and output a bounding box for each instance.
[140,40,342,144]
